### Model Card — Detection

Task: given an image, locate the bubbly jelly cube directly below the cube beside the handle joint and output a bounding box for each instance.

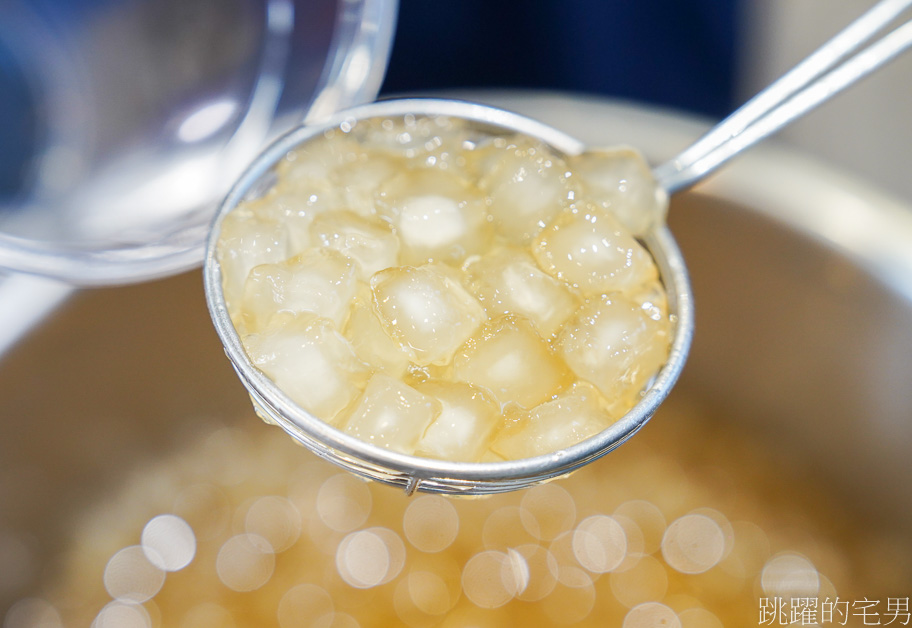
[532,203,658,294]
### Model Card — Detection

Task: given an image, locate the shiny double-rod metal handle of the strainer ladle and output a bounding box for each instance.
[655,0,912,193]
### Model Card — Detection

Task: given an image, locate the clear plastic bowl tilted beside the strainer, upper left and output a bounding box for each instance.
[0,0,396,285]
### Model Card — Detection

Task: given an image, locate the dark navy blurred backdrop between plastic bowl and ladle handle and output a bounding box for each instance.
[383,0,740,117]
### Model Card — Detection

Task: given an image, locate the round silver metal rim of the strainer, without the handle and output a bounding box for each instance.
[204,98,693,494]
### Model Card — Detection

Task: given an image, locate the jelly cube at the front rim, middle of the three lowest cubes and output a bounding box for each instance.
[415,381,501,462]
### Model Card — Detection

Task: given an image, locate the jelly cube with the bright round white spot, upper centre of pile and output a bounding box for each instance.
[377,170,490,265]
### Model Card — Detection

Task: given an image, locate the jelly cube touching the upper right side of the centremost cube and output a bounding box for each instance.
[468,248,579,338]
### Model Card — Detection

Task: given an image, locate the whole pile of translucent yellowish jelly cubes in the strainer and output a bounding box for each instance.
[218,116,671,462]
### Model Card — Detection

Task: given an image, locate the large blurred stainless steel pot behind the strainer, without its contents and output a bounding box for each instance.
[0,94,912,617]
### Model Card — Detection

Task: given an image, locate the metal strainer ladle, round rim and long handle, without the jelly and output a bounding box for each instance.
[205,0,912,495]
